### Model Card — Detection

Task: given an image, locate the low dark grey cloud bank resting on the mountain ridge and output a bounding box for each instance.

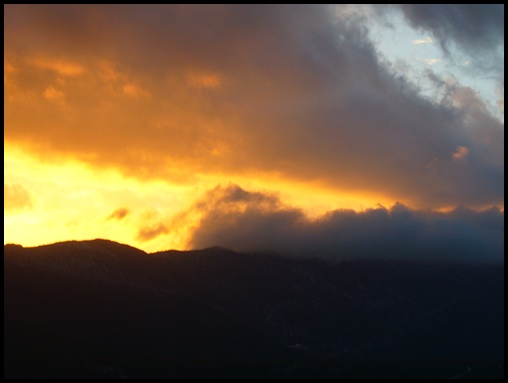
[189,185,504,262]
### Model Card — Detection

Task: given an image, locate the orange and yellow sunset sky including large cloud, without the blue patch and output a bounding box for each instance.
[4,6,504,251]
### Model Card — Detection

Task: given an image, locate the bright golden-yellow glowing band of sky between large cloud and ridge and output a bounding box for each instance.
[4,142,392,252]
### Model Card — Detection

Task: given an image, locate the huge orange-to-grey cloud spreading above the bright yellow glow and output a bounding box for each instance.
[4,5,504,207]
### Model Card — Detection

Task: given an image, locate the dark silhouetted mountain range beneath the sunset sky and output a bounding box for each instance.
[4,240,504,378]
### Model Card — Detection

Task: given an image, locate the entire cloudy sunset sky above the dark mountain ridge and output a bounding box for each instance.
[4,5,504,260]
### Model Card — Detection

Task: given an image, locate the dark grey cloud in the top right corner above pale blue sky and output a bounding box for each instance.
[396,4,504,70]
